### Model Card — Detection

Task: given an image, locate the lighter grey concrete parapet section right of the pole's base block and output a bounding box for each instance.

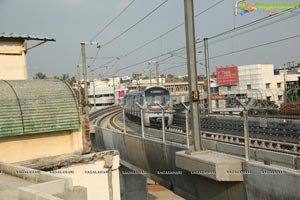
[243,161,300,200]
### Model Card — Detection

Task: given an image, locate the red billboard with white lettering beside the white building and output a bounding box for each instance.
[217,66,239,86]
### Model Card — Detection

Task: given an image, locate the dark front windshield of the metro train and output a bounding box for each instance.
[145,89,170,106]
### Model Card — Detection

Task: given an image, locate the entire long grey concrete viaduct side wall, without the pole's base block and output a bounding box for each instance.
[95,128,300,200]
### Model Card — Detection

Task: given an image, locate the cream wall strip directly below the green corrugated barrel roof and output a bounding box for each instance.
[0,130,83,163]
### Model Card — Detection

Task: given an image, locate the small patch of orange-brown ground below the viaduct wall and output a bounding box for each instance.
[148,184,184,200]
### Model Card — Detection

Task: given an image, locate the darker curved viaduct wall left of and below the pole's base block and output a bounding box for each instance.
[96,128,244,200]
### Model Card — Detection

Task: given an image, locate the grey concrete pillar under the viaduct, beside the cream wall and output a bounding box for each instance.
[119,165,148,200]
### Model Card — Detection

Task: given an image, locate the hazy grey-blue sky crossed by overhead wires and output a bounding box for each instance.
[0,0,300,79]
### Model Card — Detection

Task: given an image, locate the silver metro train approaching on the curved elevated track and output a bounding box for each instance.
[124,86,174,127]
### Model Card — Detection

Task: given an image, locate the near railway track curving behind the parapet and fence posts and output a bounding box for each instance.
[90,106,300,168]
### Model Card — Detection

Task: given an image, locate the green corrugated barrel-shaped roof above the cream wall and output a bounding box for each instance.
[0,79,79,137]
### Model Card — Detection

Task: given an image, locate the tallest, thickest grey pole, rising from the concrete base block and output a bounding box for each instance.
[184,0,202,151]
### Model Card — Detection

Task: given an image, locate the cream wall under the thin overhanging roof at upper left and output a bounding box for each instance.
[0,39,27,80]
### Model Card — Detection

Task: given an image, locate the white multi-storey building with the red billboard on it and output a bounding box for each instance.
[212,64,285,112]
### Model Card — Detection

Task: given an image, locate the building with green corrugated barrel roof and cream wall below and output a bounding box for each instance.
[0,79,83,162]
